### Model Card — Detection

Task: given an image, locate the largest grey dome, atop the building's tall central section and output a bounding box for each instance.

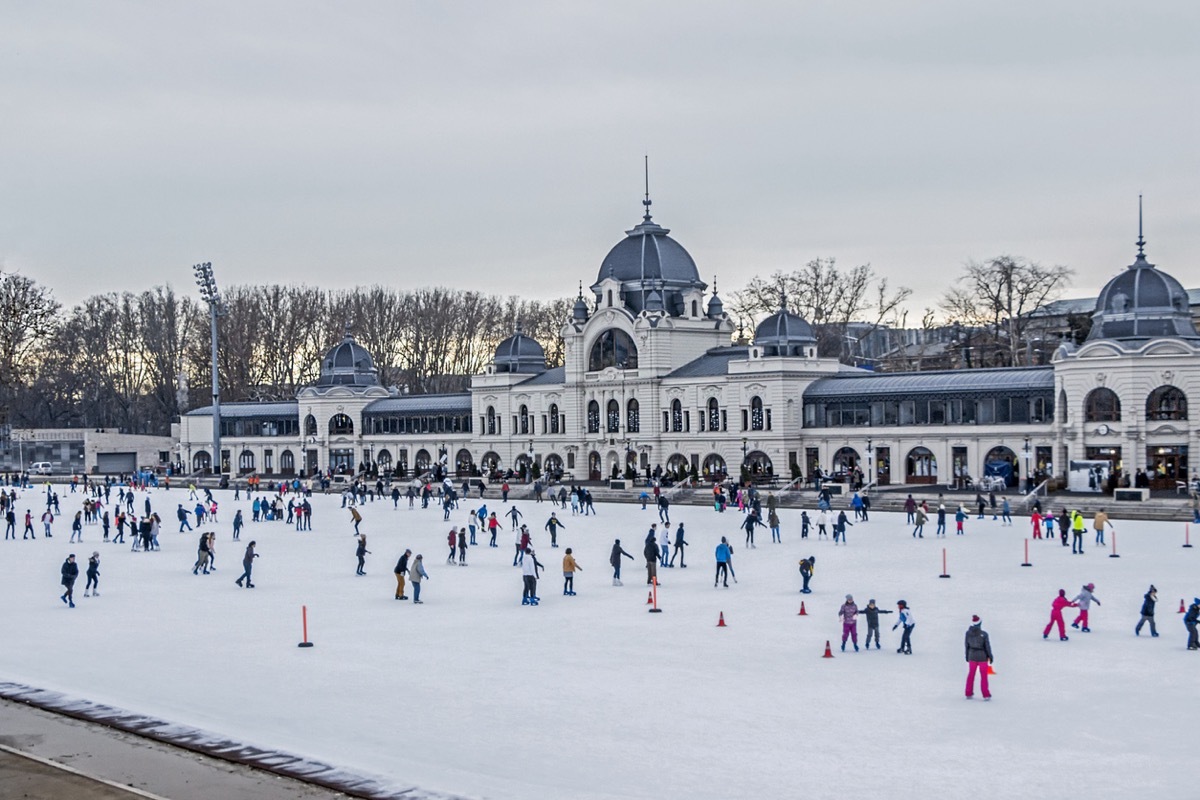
[593,196,706,317]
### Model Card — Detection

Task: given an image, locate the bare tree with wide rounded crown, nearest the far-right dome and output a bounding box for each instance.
[942,255,1074,366]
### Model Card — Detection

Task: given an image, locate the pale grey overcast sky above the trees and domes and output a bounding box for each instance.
[0,0,1200,318]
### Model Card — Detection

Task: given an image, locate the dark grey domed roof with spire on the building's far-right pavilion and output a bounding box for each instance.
[1087,209,1200,341]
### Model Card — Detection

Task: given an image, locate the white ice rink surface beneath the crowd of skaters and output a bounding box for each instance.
[0,488,1200,799]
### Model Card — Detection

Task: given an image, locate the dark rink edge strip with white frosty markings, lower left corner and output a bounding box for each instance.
[0,681,464,800]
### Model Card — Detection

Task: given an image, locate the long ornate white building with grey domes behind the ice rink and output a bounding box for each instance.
[180,199,1200,488]
